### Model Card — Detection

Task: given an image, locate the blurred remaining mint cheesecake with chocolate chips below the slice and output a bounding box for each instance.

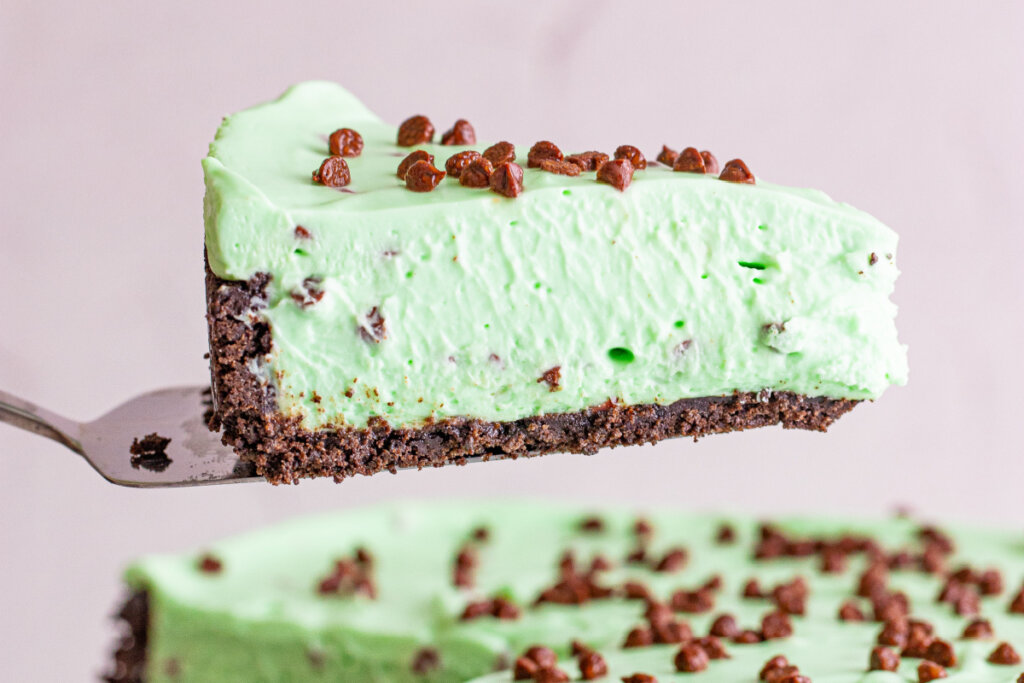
[111,502,1024,683]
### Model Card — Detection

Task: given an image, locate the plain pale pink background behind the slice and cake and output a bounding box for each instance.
[0,0,1024,681]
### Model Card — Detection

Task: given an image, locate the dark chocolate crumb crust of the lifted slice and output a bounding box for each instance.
[206,265,859,483]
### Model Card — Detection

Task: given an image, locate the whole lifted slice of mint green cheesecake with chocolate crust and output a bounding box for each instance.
[203,82,907,482]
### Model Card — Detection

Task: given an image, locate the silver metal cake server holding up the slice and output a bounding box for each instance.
[0,386,256,488]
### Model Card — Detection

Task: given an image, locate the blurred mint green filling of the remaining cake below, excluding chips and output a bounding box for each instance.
[127,502,1024,683]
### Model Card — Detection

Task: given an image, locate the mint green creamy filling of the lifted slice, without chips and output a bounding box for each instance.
[203,82,907,429]
